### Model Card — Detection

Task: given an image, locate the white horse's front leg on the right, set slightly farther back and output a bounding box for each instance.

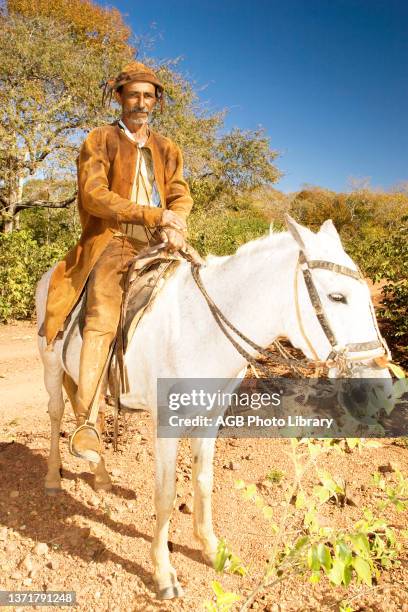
[191,437,218,565]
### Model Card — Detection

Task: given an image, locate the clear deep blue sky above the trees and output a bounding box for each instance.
[101,0,408,191]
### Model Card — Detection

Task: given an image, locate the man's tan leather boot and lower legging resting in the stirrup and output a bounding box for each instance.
[70,331,111,463]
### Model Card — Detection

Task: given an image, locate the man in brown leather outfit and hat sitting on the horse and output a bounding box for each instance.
[44,61,192,459]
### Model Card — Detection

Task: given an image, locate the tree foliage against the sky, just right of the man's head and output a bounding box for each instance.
[144,58,280,208]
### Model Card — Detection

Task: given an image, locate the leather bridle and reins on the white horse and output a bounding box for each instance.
[191,249,391,376]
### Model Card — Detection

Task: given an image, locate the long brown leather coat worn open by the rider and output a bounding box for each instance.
[44,124,193,344]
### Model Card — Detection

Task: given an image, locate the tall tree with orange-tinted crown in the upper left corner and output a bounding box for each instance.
[0,0,133,231]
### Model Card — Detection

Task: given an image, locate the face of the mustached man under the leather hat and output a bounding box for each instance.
[116,82,157,125]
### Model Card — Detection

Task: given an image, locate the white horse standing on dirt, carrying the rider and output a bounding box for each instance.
[37,216,390,599]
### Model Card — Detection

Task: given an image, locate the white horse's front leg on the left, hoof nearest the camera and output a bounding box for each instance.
[150,438,183,599]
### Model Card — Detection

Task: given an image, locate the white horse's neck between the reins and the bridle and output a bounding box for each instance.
[202,233,297,352]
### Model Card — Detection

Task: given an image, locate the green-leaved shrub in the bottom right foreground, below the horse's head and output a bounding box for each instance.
[208,439,407,611]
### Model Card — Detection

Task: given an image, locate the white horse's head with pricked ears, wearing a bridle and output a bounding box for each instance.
[286,215,390,378]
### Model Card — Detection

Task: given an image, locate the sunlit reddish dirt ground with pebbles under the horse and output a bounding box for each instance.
[0,323,408,612]
